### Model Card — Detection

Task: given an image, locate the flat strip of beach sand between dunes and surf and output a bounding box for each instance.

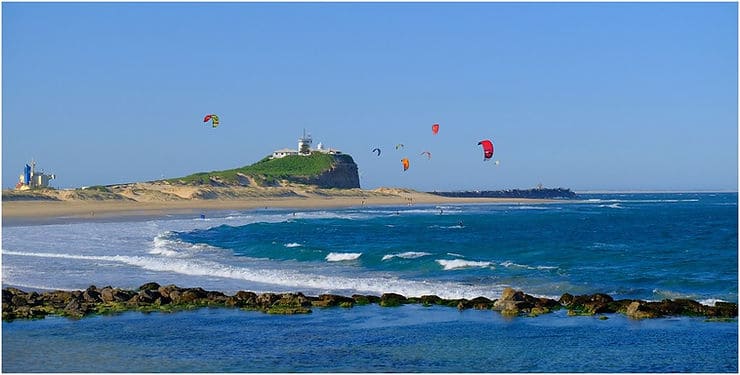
[2,192,563,226]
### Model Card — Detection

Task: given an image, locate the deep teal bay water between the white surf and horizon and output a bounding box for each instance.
[172,194,738,302]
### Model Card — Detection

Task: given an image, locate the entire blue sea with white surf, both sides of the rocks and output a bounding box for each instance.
[2,193,738,373]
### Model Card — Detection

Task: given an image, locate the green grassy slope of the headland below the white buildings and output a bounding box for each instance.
[166,152,354,186]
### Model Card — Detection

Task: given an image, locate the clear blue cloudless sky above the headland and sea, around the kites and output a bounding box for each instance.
[2,2,738,191]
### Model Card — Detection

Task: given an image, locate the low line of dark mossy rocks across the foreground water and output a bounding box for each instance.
[2,283,738,320]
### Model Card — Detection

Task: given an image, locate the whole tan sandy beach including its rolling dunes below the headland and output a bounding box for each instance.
[2,183,547,225]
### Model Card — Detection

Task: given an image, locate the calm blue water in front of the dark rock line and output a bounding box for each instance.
[3,305,738,373]
